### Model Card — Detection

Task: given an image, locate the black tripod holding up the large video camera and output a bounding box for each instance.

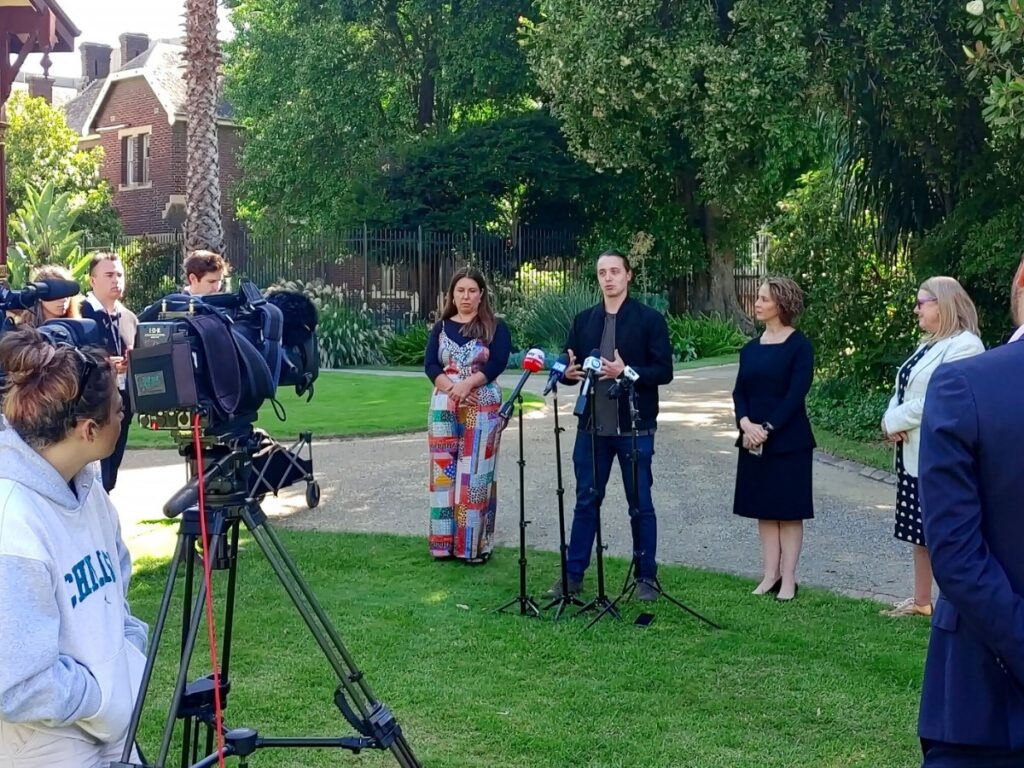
[111,438,420,768]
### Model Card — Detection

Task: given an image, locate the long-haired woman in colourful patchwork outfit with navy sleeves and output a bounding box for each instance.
[424,267,512,563]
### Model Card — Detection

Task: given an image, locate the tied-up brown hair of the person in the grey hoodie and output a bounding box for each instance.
[0,328,117,452]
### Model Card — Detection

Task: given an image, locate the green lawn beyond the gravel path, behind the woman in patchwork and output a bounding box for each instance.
[128,371,543,449]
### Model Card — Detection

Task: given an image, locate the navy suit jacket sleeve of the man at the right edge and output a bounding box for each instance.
[920,366,1024,686]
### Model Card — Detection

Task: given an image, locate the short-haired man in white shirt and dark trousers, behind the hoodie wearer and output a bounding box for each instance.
[82,252,138,493]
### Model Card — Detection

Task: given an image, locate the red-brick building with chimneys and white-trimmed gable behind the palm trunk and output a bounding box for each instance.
[65,34,242,240]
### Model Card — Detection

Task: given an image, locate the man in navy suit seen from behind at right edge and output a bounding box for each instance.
[919,272,1024,768]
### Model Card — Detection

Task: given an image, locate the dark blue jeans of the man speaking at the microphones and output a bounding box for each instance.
[567,430,657,582]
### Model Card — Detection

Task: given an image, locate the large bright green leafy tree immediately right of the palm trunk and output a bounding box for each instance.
[227,0,531,227]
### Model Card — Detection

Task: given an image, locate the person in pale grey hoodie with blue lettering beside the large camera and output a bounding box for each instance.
[0,328,146,768]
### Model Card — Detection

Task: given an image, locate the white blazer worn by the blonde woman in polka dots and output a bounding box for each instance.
[882,331,985,477]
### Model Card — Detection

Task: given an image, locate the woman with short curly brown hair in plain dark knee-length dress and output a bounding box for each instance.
[732,278,815,600]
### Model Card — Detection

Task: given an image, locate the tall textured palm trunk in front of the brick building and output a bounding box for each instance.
[185,0,224,253]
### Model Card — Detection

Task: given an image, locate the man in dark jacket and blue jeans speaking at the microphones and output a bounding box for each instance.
[548,251,673,601]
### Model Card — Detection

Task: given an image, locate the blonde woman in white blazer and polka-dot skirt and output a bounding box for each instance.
[882,276,985,616]
